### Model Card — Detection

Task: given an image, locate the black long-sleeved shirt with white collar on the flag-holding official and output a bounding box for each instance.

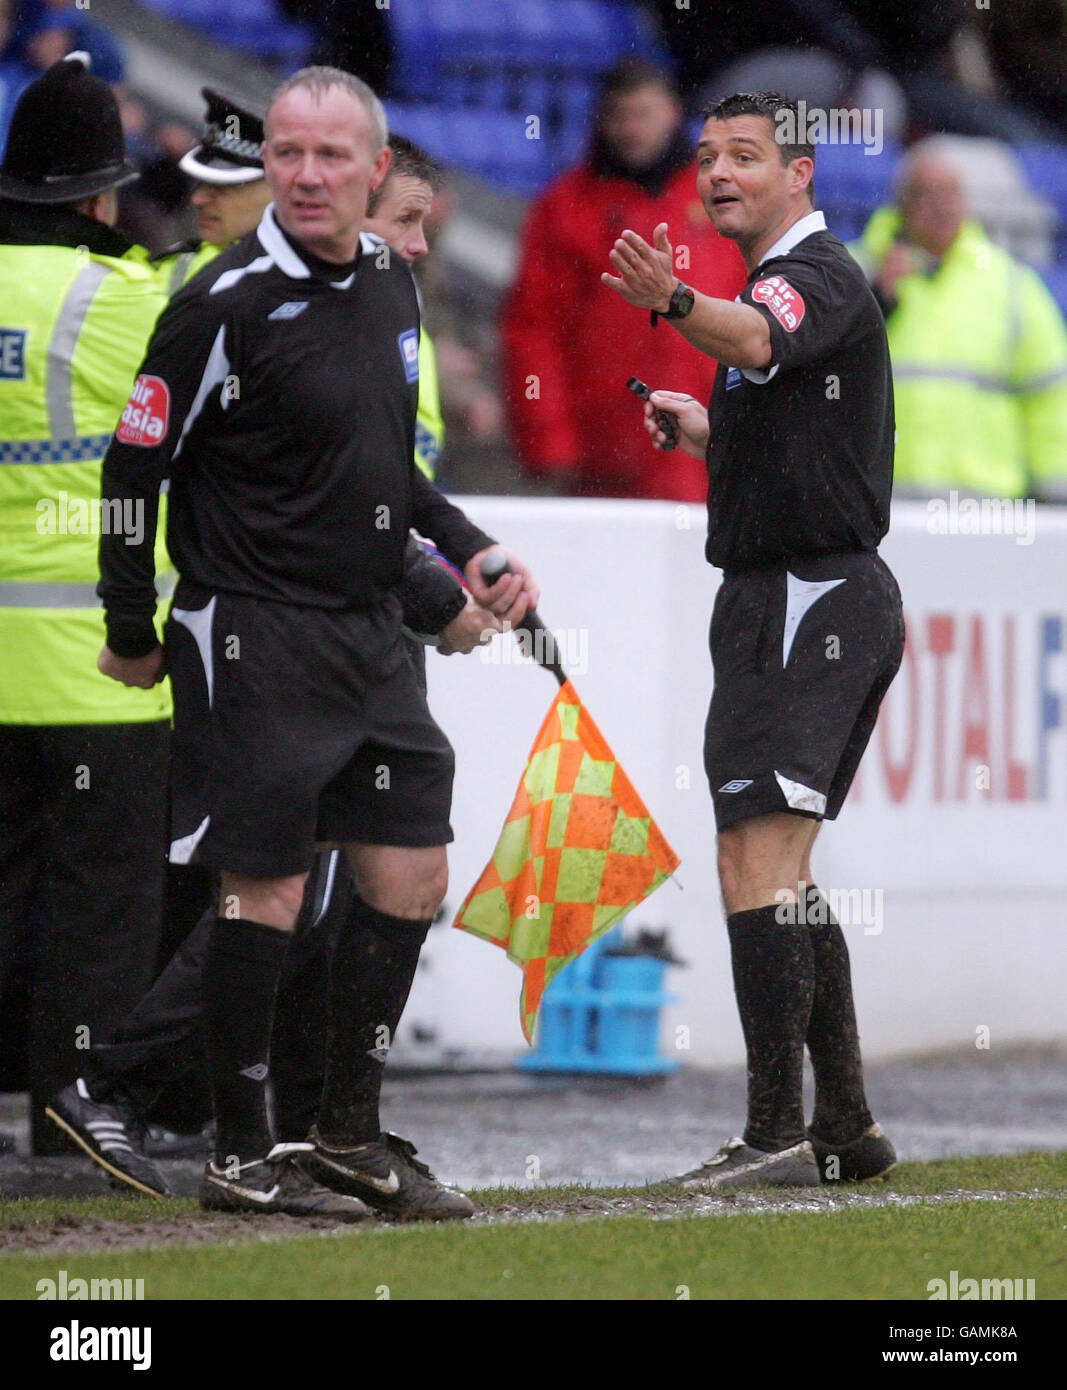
[99,209,492,657]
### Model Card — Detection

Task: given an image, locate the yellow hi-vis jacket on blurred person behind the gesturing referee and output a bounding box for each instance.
[849,209,1067,500]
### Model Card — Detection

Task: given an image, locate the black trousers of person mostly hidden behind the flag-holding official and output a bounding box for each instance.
[82,851,351,1140]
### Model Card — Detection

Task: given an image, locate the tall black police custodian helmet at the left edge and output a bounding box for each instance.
[0,53,138,203]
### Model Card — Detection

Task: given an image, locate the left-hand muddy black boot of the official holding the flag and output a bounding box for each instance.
[200,1144,374,1220]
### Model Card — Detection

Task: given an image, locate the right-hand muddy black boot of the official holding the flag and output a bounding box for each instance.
[301,1129,474,1220]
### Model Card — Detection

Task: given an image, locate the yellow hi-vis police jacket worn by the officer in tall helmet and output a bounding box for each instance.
[0,234,172,724]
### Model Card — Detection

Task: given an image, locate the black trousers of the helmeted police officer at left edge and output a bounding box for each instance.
[0,720,169,1154]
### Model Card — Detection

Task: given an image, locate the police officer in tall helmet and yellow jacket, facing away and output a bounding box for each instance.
[0,54,171,1152]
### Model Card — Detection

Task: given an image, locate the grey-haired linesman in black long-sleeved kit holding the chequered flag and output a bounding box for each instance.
[100,68,536,1220]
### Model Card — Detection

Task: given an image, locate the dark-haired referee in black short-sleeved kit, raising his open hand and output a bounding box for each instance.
[603,92,904,1188]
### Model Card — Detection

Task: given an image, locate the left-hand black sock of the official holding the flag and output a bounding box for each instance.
[203,917,290,1165]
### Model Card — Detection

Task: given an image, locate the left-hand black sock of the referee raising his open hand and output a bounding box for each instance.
[727,906,814,1152]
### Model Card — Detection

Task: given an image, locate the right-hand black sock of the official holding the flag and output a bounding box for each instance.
[317,895,429,1148]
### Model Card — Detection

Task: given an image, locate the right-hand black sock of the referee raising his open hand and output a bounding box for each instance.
[804,884,874,1144]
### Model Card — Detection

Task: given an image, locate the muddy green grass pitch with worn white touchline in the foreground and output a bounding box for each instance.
[0,1152,1067,1300]
